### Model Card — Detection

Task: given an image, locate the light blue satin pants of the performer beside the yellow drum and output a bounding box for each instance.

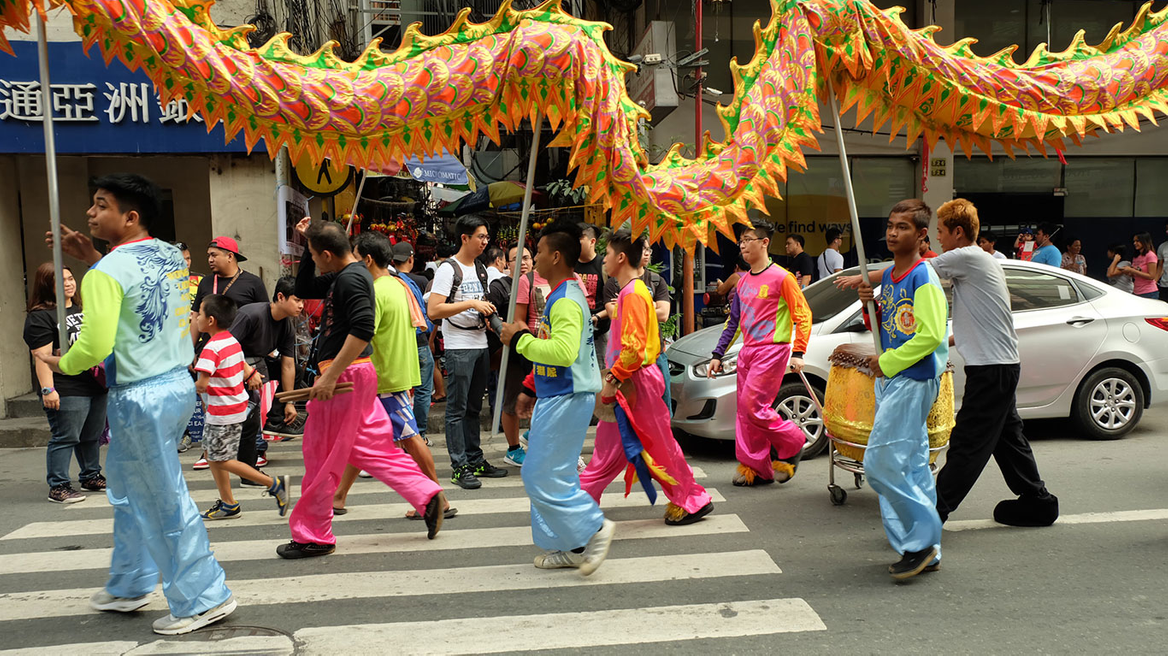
[864,376,941,560]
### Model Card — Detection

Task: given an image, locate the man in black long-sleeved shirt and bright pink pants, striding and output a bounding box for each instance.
[276,217,446,558]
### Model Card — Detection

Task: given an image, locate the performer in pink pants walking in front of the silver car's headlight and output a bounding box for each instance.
[709,222,812,486]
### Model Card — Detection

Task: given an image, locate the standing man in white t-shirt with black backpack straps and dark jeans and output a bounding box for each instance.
[426,215,507,490]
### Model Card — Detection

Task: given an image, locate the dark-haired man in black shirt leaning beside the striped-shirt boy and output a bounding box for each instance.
[230,277,304,467]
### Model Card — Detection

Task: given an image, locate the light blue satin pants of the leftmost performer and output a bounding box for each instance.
[105,369,231,617]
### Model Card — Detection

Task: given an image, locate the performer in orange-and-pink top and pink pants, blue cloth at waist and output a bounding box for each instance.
[580,229,714,525]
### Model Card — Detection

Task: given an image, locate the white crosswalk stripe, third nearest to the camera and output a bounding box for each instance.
[0,515,750,575]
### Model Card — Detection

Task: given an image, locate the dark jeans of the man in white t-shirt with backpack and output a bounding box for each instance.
[446,349,491,468]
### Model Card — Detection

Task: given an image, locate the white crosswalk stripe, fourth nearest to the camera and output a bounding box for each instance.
[0,488,725,540]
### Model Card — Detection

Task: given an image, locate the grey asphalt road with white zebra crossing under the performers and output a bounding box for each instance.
[0,407,1168,654]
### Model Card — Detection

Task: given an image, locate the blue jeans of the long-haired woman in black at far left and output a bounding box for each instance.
[44,395,105,488]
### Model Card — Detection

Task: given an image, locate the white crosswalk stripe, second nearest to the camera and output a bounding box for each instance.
[0,549,783,616]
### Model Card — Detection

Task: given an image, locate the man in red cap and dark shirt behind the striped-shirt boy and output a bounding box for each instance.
[189,237,270,469]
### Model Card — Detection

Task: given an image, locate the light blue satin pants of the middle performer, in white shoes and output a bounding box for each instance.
[520,393,604,551]
